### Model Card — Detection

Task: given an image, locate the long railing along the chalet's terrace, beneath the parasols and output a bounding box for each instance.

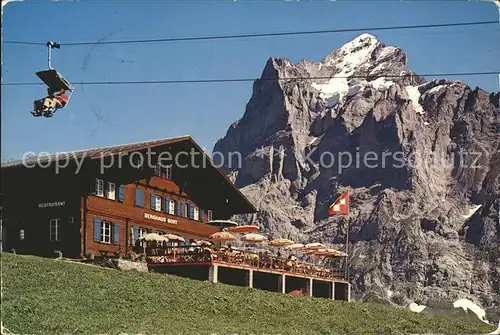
[146,245,346,279]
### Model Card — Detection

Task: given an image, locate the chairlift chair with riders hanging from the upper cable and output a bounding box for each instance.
[32,42,74,117]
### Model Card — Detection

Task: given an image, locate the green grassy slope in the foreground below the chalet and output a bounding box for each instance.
[1,253,494,334]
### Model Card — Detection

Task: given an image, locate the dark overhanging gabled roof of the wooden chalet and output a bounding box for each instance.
[2,136,257,219]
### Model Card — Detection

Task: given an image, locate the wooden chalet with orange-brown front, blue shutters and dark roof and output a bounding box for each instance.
[1,136,256,258]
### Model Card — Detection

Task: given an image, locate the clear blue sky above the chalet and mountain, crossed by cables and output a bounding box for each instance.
[2,0,500,161]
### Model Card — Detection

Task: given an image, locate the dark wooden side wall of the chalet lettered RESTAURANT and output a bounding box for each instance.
[2,169,81,258]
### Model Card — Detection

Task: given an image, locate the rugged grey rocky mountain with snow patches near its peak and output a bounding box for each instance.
[213,34,500,314]
